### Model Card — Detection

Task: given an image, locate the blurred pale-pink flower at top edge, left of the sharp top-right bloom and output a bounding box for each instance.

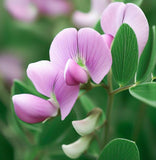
[73,0,111,27]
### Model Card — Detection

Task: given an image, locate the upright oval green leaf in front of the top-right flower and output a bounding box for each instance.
[111,24,138,86]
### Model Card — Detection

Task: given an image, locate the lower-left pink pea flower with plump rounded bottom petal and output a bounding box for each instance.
[12,61,79,123]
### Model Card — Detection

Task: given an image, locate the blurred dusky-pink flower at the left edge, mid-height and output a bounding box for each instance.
[0,54,22,84]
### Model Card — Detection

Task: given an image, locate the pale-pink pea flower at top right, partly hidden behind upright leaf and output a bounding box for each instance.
[101,2,149,55]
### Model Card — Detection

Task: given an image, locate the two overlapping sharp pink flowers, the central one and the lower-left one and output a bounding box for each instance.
[13,28,112,123]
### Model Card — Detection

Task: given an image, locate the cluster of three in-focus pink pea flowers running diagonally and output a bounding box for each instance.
[13,2,149,123]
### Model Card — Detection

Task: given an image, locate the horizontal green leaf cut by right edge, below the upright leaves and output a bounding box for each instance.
[129,82,156,107]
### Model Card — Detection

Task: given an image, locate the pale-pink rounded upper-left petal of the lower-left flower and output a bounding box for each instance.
[27,61,58,97]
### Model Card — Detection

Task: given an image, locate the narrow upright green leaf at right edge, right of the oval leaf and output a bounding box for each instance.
[136,26,156,82]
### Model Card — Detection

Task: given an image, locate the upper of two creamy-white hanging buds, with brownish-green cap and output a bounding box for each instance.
[72,108,102,136]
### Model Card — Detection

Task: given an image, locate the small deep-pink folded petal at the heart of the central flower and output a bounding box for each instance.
[64,59,88,86]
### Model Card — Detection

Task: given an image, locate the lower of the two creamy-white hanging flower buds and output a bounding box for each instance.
[62,135,92,159]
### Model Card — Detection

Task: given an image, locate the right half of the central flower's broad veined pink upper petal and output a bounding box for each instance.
[78,28,112,83]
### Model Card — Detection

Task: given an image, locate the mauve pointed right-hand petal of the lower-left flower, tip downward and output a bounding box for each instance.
[55,74,79,120]
